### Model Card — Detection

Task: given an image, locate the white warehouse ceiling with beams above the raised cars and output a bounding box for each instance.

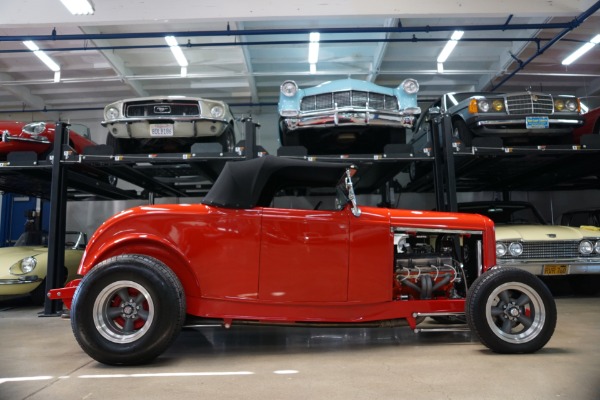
[0,0,600,119]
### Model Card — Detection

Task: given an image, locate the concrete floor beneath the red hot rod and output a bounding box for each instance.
[0,296,600,400]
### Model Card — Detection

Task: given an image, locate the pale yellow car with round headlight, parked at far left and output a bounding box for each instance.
[0,231,87,305]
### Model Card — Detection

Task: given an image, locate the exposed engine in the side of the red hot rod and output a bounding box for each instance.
[394,230,478,300]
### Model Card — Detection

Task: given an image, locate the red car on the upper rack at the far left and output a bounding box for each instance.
[0,121,96,159]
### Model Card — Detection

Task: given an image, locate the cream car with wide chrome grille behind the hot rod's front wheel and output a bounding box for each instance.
[458,201,600,276]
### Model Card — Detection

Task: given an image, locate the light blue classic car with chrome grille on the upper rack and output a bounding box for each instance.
[278,79,421,154]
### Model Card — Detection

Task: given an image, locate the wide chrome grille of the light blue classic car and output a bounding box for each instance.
[300,90,398,111]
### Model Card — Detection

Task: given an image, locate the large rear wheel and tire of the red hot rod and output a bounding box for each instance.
[71,254,186,365]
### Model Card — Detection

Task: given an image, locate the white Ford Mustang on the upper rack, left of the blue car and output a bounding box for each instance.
[102,96,236,154]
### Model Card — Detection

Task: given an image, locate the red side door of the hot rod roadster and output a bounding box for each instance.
[259,208,349,302]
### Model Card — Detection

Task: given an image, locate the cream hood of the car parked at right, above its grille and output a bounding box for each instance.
[496,225,600,241]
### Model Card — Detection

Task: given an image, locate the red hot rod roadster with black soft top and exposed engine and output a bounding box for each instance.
[49,156,556,365]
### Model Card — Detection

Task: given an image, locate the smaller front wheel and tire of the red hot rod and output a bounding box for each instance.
[465,267,556,354]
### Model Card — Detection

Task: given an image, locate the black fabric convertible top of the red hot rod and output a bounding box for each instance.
[202,155,351,208]
